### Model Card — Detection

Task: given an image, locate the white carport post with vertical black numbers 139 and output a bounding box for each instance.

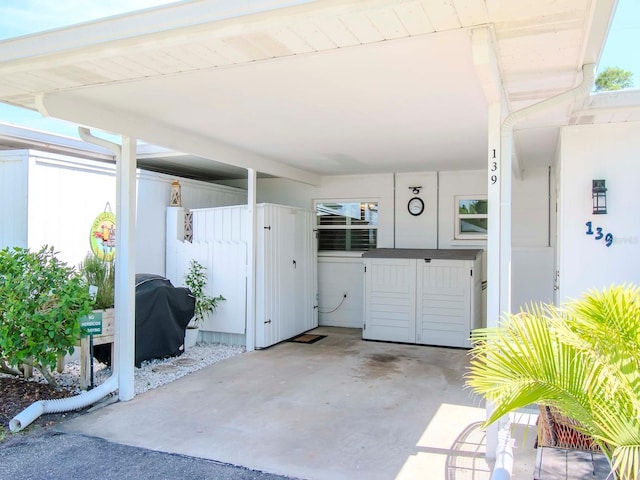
[486,102,511,458]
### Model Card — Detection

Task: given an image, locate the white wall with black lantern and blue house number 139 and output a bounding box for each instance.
[558,122,640,302]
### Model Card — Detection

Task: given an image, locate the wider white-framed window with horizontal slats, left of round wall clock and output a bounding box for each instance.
[315,200,378,252]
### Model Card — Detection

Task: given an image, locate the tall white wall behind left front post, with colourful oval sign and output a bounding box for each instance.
[0,146,246,275]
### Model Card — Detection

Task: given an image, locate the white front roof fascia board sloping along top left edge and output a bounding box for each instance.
[0,0,444,74]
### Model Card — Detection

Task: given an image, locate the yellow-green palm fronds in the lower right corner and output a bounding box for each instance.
[467,286,640,480]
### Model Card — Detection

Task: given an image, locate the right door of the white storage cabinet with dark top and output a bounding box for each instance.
[416,260,472,347]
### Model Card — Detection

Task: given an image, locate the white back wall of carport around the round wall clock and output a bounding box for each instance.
[252,167,555,327]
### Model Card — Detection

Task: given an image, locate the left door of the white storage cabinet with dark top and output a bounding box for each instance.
[362,258,416,343]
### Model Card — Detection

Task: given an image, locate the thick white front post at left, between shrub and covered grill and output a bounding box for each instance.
[114,136,136,401]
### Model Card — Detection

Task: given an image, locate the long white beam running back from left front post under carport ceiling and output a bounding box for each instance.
[37,93,321,185]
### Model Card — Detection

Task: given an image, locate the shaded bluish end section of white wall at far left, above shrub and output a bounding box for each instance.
[0,151,29,249]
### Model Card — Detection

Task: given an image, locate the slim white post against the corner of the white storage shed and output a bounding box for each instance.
[246,168,258,351]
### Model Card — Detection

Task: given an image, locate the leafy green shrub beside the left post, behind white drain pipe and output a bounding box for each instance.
[0,246,91,385]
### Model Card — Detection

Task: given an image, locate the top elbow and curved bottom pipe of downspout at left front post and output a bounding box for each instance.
[9,127,122,432]
